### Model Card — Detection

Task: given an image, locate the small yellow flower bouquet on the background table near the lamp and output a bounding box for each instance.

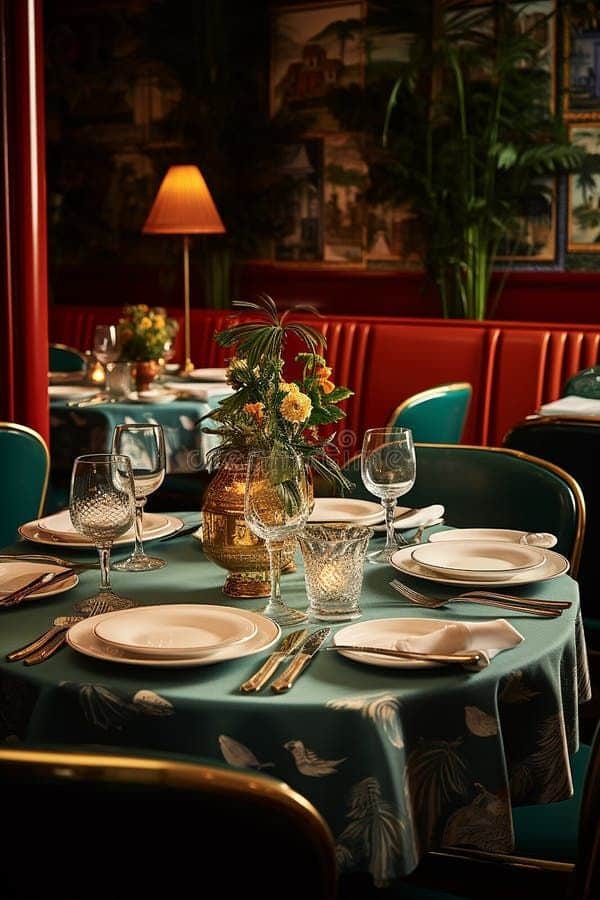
[118,303,179,362]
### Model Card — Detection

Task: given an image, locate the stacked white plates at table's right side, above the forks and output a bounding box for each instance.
[392,540,569,586]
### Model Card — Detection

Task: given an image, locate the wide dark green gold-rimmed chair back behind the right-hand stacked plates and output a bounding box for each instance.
[344,444,585,575]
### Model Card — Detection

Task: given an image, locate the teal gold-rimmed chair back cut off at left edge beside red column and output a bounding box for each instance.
[0,422,50,547]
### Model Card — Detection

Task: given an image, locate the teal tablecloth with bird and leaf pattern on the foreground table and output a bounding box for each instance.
[0,524,589,883]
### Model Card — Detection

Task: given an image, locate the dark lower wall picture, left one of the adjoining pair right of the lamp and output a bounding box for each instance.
[273,139,323,262]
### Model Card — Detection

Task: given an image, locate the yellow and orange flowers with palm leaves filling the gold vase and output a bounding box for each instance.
[203,294,353,489]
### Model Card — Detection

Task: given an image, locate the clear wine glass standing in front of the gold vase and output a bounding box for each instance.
[244,450,309,625]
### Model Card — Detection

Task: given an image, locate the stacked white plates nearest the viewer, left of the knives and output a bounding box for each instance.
[67,603,281,667]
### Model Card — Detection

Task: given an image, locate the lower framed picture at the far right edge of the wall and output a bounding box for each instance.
[567,122,600,253]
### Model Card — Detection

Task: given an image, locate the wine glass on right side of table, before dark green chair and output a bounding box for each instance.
[360,427,416,563]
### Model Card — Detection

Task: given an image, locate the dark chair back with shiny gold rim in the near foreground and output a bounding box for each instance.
[0,748,336,900]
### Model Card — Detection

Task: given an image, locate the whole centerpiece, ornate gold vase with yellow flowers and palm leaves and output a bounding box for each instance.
[202,294,352,597]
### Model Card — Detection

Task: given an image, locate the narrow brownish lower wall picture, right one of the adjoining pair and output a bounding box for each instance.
[323,134,368,264]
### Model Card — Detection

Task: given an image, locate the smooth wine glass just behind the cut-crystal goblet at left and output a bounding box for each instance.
[112,424,166,572]
